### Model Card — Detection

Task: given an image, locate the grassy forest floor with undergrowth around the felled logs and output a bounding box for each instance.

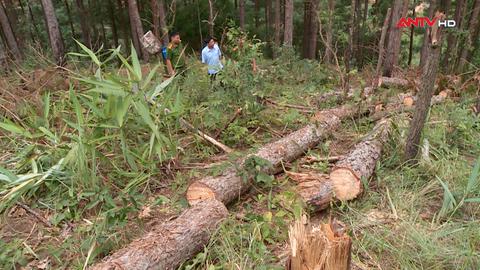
[0,52,480,269]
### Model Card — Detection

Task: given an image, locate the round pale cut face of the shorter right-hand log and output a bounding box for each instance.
[330,168,362,201]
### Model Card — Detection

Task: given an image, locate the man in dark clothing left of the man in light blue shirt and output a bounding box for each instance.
[165,32,186,76]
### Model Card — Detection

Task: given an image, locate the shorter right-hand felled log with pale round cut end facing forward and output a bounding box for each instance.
[330,119,391,201]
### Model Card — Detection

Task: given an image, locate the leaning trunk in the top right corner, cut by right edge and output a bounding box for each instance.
[457,0,480,73]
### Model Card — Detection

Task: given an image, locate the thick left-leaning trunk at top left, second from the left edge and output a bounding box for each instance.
[42,0,65,65]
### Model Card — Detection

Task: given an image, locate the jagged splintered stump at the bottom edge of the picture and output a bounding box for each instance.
[286,217,352,270]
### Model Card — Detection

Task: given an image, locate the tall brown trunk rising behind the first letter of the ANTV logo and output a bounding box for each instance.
[383,0,408,77]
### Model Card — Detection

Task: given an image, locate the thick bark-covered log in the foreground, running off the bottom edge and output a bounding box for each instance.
[90,200,228,270]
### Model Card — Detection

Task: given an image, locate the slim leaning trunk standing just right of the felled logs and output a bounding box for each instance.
[405,12,444,160]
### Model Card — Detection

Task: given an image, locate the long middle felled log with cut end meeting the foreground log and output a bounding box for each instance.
[186,106,359,205]
